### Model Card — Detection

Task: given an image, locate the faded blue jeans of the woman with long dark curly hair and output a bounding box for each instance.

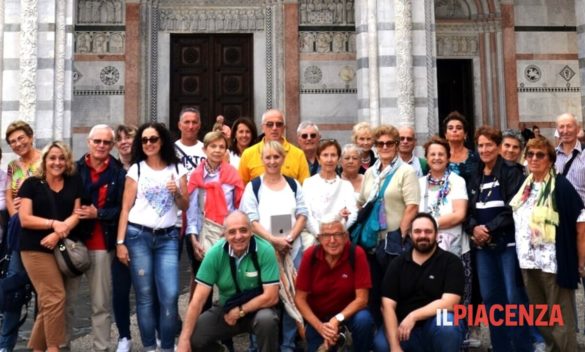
[126,224,179,351]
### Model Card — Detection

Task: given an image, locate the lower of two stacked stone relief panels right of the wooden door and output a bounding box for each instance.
[299,32,356,54]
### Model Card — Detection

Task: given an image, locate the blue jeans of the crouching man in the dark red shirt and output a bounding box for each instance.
[306,308,374,352]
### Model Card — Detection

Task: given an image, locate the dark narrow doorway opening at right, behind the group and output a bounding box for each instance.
[437,59,475,143]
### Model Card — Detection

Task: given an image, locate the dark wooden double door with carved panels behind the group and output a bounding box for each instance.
[170,34,254,139]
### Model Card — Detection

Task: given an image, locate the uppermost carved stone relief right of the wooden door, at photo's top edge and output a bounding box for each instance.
[299,0,355,26]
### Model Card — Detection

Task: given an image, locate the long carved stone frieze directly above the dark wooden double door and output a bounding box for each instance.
[160,8,266,33]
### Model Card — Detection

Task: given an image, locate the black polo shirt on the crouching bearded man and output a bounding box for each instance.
[382,247,464,326]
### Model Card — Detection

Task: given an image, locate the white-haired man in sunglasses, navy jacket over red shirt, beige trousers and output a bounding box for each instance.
[67,125,125,351]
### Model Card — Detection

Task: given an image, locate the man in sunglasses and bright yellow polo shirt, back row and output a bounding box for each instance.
[239,109,309,184]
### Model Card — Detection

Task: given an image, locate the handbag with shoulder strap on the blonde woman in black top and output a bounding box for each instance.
[42,182,91,277]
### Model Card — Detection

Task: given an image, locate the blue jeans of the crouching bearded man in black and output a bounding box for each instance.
[373,312,465,352]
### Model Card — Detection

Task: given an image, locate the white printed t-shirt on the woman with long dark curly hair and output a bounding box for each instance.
[126,161,187,229]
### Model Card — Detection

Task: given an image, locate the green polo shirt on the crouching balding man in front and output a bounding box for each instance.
[195,236,280,306]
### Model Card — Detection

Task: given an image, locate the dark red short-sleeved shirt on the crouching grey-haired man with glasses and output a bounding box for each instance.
[296,241,372,321]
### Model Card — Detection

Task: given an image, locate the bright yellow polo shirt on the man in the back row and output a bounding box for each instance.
[238,139,310,184]
